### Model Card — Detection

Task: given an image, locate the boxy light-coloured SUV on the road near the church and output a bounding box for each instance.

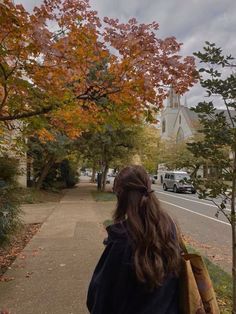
[163,171,196,194]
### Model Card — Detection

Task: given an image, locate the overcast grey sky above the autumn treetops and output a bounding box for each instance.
[15,0,236,107]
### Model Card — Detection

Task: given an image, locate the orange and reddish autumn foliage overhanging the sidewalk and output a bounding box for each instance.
[0,0,195,137]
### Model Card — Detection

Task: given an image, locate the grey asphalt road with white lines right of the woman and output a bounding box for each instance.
[152,184,232,272]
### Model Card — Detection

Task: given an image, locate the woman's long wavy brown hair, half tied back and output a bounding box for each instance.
[113,166,180,289]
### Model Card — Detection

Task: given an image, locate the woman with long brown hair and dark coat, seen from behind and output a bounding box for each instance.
[87,166,181,314]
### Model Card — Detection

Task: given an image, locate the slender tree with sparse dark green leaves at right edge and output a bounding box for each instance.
[188,42,236,313]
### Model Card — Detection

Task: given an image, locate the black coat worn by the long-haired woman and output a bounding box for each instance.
[87,224,179,314]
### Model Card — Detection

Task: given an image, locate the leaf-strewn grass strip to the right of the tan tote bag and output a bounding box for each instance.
[187,245,232,314]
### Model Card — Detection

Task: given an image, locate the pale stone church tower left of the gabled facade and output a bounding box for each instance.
[161,87,180,139]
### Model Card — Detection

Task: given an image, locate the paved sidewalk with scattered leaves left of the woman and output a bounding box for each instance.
[0,183,112,314]
